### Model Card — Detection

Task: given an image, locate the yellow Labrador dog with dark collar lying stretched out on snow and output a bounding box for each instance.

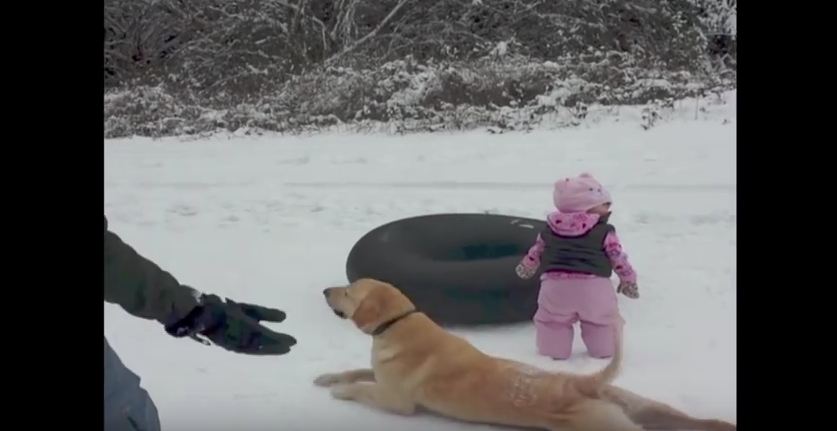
[314,279,736,431]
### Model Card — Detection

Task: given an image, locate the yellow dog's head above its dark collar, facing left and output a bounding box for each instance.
[323,278,415,334]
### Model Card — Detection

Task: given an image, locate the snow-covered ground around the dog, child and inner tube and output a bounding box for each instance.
[104,93,736,431]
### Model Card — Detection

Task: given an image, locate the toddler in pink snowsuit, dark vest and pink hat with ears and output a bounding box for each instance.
[516,173,639,359]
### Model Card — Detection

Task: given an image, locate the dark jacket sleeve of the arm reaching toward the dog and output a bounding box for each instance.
[105,217,198,324]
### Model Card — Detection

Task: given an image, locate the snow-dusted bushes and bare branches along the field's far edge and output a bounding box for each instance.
[104,0,736,137]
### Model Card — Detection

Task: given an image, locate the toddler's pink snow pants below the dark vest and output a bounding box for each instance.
[533,277,619,359]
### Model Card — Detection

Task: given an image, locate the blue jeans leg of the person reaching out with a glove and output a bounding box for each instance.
[105,338,160,431]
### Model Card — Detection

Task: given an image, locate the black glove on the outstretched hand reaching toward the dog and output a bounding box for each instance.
[166,295,296,355]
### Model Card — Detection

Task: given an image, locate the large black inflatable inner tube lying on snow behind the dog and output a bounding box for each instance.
[346,214,544,325]
